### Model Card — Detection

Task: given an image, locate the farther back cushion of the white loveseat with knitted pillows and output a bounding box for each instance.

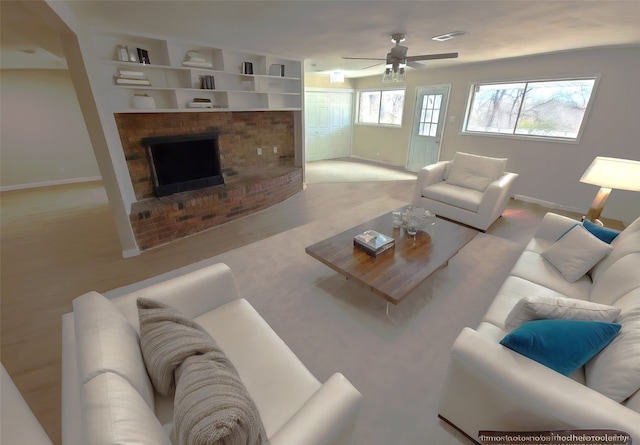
[73,292,155,410]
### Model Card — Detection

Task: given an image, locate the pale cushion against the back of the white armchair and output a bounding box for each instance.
[447,153,507,192]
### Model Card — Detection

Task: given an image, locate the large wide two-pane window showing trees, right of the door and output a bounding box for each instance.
[464,77,596,141]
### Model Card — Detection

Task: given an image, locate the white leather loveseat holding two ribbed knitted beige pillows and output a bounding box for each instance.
[62,264,362,445]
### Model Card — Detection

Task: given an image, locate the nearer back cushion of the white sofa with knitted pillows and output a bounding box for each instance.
[84,372,171,445]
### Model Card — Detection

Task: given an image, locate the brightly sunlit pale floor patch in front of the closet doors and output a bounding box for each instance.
[305,158,416,184]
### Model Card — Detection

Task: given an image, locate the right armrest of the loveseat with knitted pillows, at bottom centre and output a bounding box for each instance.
[269,373,362,445]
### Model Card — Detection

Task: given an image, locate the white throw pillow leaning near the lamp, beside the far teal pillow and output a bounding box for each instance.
[542,224,613,283]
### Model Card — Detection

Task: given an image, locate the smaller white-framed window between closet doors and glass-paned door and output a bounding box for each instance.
[356,89,404,126]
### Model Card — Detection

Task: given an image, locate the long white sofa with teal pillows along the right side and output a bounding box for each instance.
[439,213,640,443]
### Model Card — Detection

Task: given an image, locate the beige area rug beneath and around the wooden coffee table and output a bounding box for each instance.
[110,198,524,445]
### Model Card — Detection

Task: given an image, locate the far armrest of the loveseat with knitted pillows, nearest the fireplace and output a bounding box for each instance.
[104,263,240,330]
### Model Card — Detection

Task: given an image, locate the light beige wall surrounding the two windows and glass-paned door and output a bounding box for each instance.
[353,47,640,222]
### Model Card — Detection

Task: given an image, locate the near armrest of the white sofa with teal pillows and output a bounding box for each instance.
[439,328,640,442]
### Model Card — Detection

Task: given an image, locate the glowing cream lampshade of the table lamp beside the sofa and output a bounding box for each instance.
[580,156,640,192]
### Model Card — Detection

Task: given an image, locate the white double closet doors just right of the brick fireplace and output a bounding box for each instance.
[305,91,353,162]
